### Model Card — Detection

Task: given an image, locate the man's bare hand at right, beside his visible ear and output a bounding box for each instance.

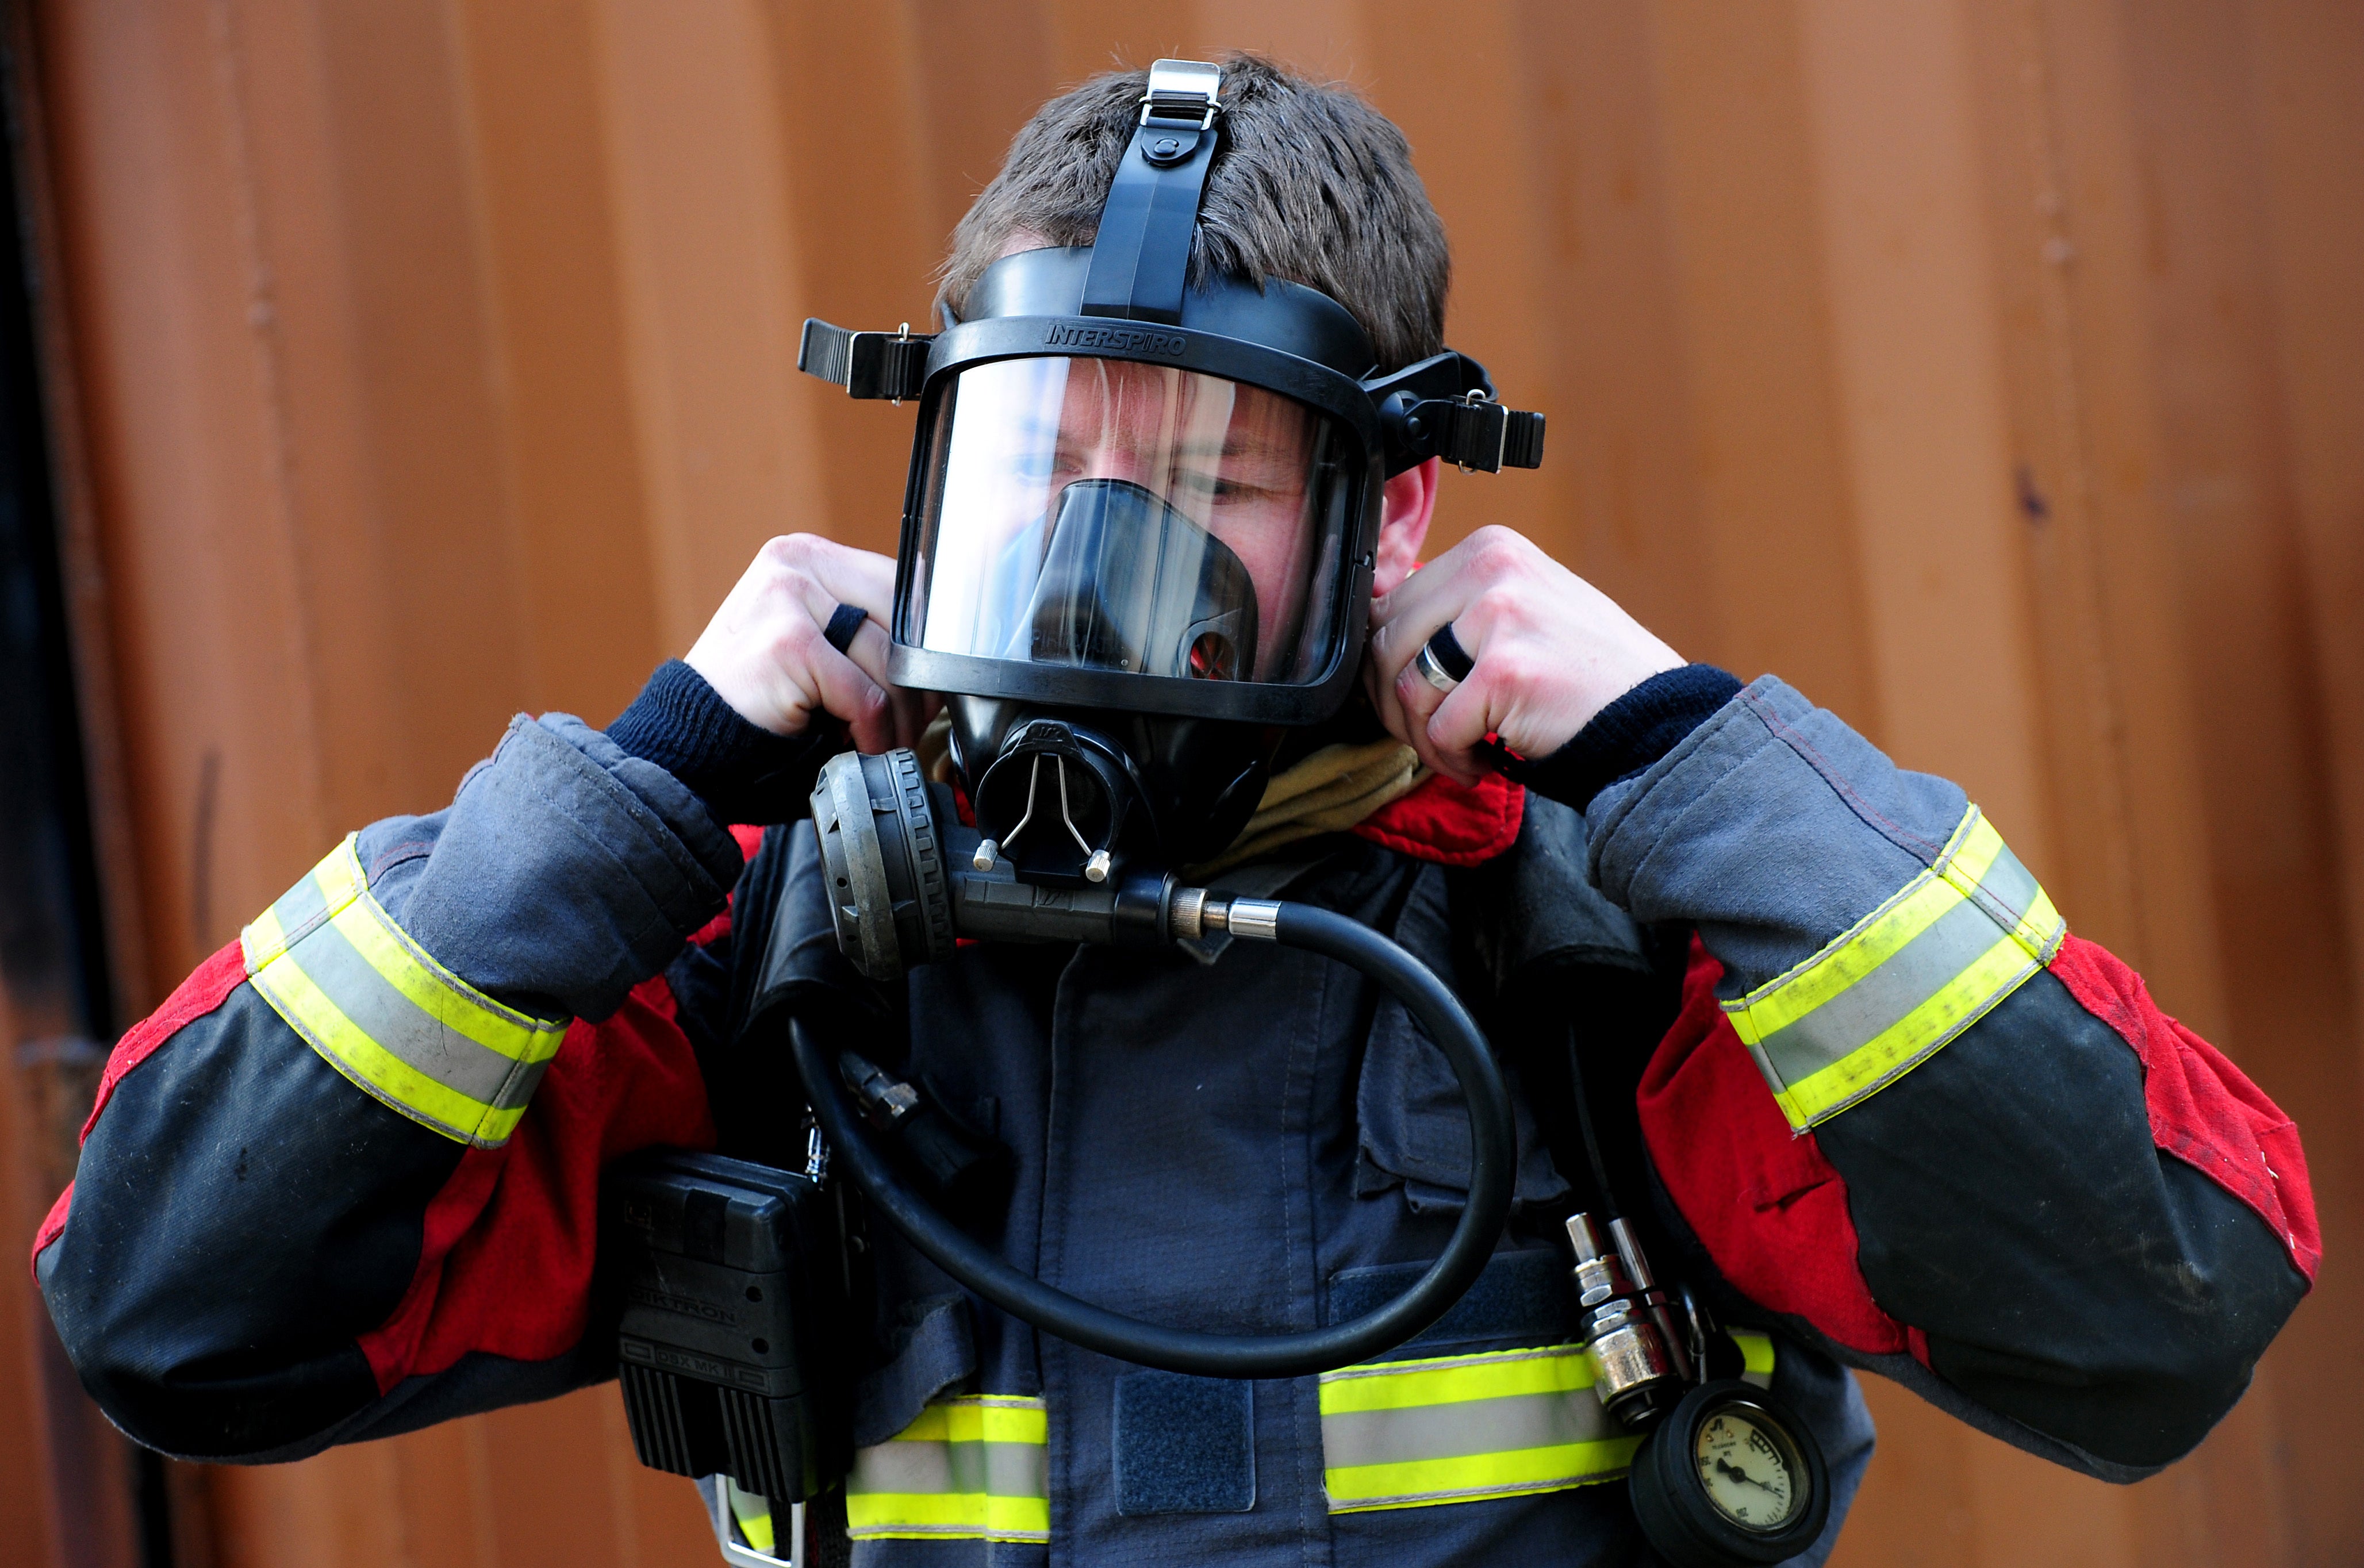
[1362,528,1683,785]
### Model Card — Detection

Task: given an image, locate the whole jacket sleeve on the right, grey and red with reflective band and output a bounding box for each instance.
[1586,677,2319,1478]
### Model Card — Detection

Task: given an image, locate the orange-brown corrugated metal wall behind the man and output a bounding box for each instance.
[0,0,2364,1568]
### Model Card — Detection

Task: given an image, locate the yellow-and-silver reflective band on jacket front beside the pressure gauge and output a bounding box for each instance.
[1322,1346,1641,1513]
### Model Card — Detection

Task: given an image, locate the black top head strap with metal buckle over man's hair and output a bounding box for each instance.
[1083,59,1222,326]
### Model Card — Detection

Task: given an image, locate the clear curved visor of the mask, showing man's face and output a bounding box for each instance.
[903,357,1352,686]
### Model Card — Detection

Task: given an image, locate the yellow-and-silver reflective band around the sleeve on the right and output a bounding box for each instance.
[1724,806,2068,1133]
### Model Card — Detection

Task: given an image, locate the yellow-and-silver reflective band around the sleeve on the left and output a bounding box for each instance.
[239,835,567,1147]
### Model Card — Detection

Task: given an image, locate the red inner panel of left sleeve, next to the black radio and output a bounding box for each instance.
[359,974,714,1393]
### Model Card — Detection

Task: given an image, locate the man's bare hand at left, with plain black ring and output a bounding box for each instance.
[683,535,934,752]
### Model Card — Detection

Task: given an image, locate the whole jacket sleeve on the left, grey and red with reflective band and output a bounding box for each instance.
[36,714,740,1462]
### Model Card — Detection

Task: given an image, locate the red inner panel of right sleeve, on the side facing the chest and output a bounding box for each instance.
[1636,939,1910,1355]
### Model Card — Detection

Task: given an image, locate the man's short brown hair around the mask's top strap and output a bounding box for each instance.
[941,55,1452,371]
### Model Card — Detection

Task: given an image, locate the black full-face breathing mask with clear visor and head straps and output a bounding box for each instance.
[799,62,1544,885]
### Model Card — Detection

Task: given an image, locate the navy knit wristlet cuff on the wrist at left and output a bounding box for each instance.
[608,660,842,823]
